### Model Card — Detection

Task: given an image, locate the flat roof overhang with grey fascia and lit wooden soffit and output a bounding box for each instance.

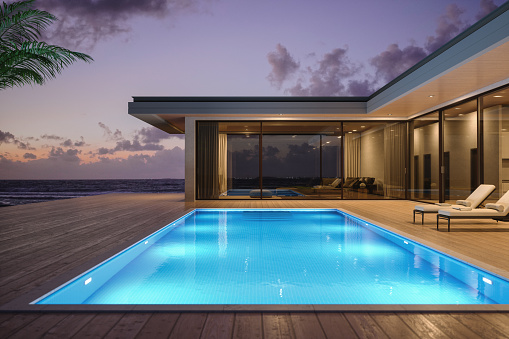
[128,2,509,134]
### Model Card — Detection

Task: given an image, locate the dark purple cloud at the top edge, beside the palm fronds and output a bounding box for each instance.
[32,0,207,50]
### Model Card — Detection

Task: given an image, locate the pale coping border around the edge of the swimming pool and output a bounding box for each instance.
[0,208,509,312]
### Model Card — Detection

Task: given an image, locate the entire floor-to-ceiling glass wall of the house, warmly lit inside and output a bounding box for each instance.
[195,86,509,203]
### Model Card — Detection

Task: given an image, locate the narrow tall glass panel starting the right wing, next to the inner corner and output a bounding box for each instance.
[408,112,439,202]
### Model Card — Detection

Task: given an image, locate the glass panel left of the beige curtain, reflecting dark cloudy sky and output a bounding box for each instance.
[262,121,341,199]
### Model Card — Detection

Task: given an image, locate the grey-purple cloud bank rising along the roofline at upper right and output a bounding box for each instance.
[267,0,497,96]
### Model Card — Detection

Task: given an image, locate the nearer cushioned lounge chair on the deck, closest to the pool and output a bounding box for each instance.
[437,191,509,232]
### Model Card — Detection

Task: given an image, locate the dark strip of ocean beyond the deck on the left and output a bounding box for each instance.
[0,179,184,207]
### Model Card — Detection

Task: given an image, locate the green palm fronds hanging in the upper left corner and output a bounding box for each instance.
[0,0,93,90]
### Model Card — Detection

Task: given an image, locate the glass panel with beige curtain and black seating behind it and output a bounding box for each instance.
[343,122,407,199]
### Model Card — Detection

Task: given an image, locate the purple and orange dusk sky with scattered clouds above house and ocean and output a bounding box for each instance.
[0,0,504,180]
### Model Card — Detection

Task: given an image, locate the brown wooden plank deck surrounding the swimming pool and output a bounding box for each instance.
[0,194,509,339]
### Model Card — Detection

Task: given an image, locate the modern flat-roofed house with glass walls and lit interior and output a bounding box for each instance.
[129,2,509,202]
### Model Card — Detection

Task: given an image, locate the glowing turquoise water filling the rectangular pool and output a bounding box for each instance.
[32,209,509,304]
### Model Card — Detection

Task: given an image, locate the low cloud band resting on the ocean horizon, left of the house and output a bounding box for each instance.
[0,147,184,179]
